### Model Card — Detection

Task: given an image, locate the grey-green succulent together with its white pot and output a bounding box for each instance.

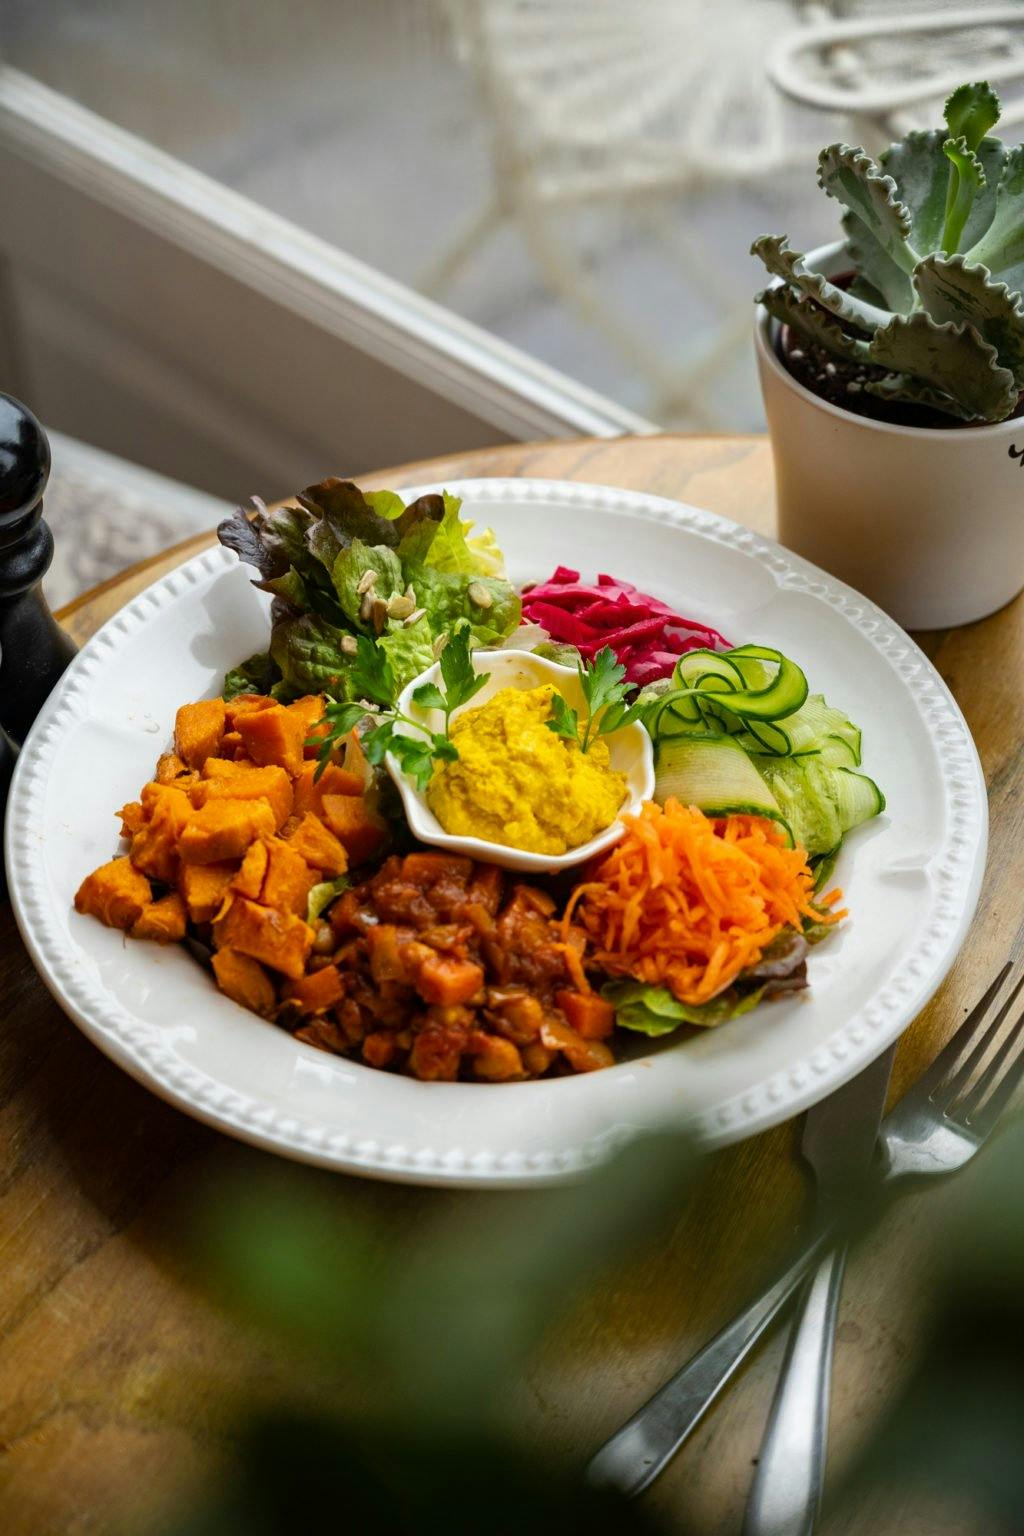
[751,83,1024,628]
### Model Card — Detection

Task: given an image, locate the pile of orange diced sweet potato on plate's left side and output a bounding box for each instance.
[75,694,387,1017]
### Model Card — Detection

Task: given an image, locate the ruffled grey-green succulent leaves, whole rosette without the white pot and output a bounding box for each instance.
[751,81,1024,421]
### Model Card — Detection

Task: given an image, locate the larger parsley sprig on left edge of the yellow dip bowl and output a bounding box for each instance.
[312,625,490,790]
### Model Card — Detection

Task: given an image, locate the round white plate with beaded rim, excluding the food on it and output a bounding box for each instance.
[6,479,987,1186]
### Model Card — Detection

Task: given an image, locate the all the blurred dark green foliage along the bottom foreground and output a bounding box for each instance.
[163,1123,1024,1536]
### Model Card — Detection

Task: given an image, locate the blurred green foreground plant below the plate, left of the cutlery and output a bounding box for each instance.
[173,1137,699,1536]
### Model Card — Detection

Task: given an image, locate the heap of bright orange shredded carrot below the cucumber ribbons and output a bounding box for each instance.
[562,800,846,1003]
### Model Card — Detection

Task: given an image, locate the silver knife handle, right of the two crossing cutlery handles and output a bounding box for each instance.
[743,1246,846,1536]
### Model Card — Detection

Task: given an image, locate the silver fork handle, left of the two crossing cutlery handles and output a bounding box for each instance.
[586,1230,829,1498]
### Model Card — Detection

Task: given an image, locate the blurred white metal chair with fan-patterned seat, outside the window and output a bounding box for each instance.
[418,0,835,429]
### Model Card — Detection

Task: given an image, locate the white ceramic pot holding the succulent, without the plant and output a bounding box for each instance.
[755,243,1024,630]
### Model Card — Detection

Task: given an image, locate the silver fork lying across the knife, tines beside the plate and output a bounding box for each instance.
[586,940,1024,1499]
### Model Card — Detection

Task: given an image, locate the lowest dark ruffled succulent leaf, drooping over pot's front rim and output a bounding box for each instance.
[869,310,1018,421]
